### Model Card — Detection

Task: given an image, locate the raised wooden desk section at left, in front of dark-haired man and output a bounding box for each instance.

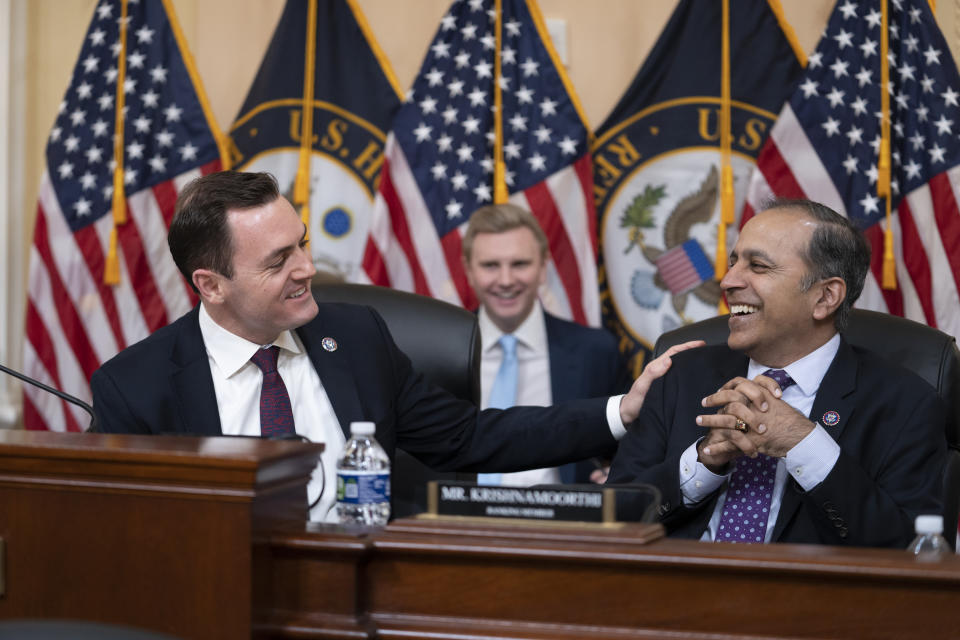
[0,430,323,640]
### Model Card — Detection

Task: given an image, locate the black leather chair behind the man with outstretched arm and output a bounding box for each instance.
[313,282,480,518]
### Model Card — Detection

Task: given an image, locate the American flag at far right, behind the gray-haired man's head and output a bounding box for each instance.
[743,0,960,336]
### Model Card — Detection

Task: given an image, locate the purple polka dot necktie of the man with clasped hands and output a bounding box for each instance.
[716,369,794,542]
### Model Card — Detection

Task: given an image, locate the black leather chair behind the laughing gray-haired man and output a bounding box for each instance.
[653,309,960,546]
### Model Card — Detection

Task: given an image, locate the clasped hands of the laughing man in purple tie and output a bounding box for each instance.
[697,375,815,474]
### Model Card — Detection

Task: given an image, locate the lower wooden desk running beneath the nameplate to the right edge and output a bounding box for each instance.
[254,520,960,640]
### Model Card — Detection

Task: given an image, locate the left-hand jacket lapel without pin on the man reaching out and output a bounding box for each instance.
[170,305,223,436]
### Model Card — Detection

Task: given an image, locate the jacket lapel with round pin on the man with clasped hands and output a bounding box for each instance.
[771,338,859,541]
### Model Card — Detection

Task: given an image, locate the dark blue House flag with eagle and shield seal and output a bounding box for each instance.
[593,0,802,374]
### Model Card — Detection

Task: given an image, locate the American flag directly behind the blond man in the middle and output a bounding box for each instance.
[363,0,600,325]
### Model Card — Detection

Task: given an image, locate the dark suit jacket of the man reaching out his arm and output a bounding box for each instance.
[90,303,615,471]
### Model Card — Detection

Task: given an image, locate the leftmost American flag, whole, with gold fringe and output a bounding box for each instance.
[24,0,220,431]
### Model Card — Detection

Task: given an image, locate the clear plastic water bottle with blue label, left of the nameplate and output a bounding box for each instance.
[337,422,390,526]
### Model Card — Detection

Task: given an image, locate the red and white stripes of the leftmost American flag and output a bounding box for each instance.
[24,161,220,431]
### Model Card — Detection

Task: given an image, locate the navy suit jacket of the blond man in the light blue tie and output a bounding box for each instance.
[543,312,632,483]
